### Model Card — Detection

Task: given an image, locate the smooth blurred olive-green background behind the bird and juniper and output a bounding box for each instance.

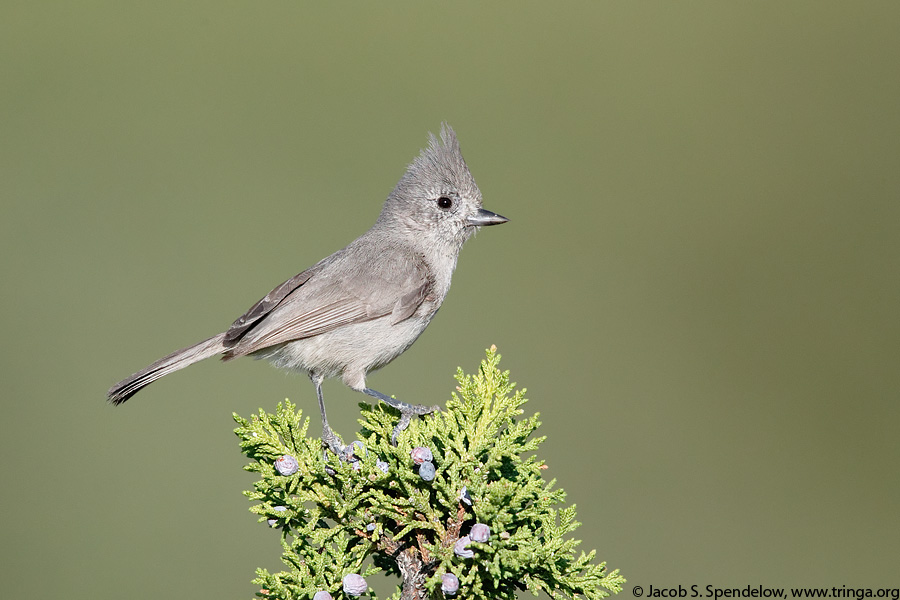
[0,0,900,599]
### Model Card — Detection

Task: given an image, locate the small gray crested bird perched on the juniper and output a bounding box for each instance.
[107,124,508,456]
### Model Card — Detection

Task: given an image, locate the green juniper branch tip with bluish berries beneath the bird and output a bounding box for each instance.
[234,347,625,600]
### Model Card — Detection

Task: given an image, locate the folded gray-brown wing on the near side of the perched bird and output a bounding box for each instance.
[219,250,432,359]
